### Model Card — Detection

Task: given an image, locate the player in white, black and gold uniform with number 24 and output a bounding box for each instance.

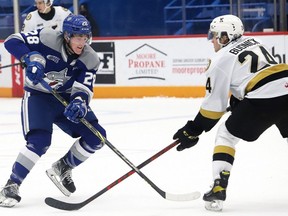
[173,15,288,211]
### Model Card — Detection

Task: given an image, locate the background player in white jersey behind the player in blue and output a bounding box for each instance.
[22,0,71,32]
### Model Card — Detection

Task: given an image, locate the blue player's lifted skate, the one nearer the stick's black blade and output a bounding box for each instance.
[46,159,76,196]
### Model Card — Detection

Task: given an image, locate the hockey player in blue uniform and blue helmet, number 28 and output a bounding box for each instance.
[0,15,106,207]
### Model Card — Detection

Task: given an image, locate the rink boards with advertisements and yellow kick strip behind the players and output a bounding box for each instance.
[0,33,288,98]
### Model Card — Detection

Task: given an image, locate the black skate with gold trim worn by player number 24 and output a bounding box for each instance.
[203,171,230,211]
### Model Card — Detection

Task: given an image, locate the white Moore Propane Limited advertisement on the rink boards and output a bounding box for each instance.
[109,38,213,86]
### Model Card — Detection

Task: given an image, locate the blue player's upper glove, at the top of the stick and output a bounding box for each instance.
[21,51,46,85]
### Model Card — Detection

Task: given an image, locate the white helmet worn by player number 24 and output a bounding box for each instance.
[208,14,244,43]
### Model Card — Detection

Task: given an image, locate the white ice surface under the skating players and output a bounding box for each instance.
[0,98,288,216]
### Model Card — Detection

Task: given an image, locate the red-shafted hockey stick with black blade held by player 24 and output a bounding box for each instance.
[45,140,179,211]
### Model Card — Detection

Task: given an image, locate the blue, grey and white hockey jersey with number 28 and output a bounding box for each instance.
[4,28,100,103]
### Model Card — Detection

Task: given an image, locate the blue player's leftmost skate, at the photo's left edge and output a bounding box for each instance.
[0,179,21,207]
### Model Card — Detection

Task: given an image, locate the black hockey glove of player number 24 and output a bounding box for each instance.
[173,121,202,151]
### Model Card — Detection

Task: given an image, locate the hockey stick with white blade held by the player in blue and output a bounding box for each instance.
[41,80,200,208]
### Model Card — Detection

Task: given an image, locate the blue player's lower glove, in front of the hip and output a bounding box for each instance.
[64,97,87,124]
